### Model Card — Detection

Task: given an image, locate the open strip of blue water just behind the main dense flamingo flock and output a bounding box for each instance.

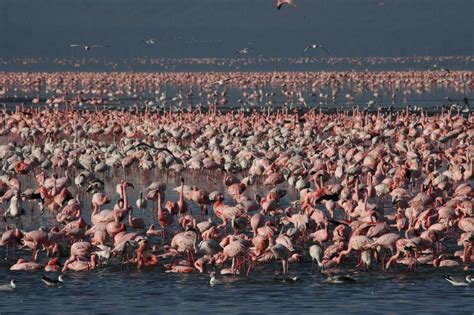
[0,85,474,113]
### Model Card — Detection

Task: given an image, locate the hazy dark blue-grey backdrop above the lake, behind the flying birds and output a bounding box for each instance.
[0,0,474,57]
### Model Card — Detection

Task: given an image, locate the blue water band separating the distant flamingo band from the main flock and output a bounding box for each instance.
[0,73,474,112]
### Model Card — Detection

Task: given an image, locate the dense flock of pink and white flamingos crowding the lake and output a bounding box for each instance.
[0,71,474,291]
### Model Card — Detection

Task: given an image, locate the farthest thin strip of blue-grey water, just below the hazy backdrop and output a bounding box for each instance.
[0,55,474,72]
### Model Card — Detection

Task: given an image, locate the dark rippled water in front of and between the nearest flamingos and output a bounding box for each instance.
[0,169,474,314]
